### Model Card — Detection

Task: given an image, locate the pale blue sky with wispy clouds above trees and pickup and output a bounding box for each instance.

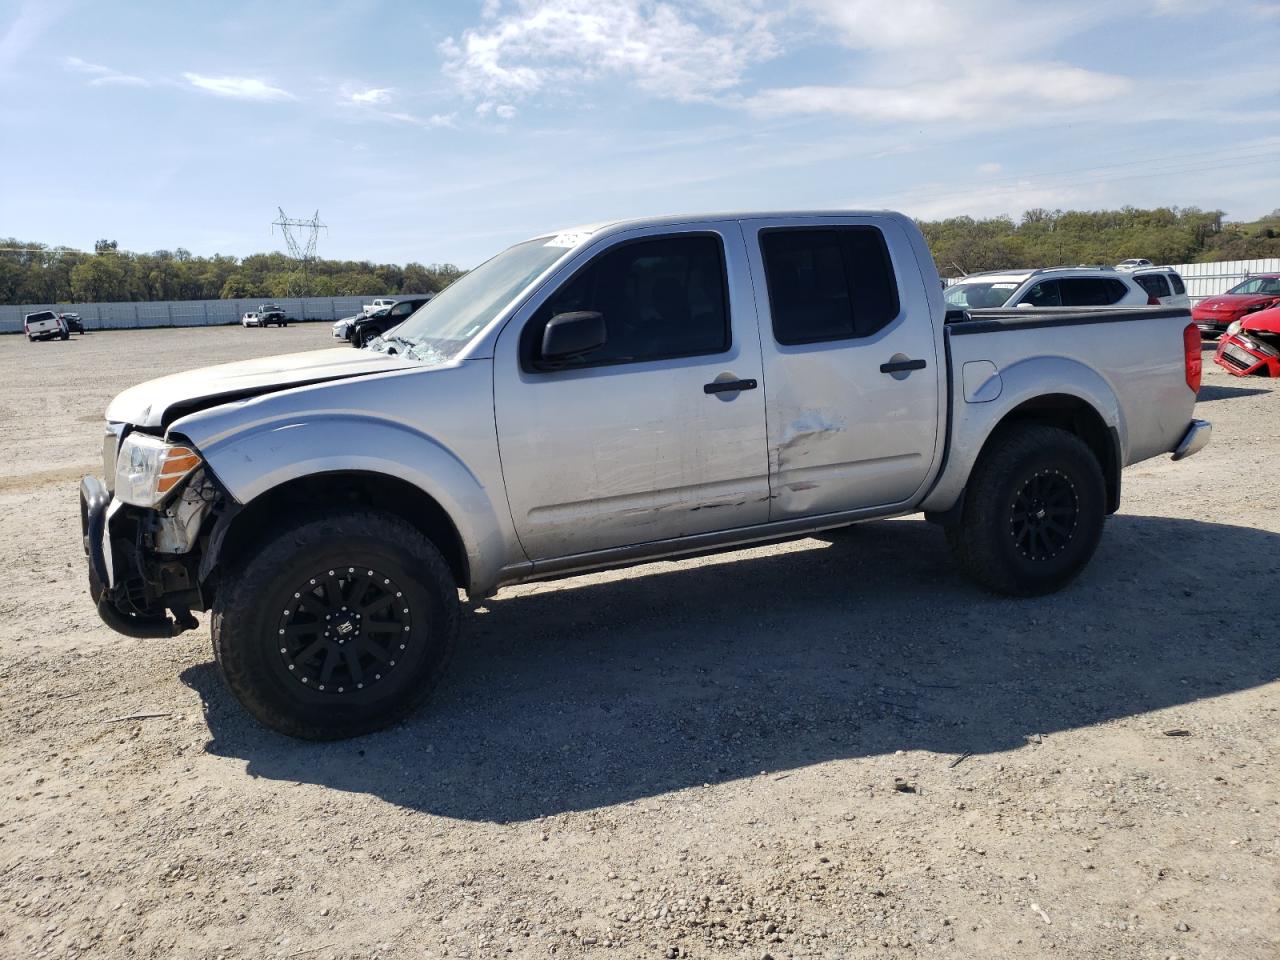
[0,0,1280,266]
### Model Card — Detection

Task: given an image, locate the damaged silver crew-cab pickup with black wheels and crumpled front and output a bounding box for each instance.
[81,212,1210,739]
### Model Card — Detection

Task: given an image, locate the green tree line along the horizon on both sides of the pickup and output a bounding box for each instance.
[0,207,1280,303]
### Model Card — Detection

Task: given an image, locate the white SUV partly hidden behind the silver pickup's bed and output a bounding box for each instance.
[946,266,1158,310]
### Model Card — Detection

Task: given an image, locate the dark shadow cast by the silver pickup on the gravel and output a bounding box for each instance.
[183,516,1280,822]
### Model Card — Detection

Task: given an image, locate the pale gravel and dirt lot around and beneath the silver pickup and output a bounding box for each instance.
[0,325,1280,960]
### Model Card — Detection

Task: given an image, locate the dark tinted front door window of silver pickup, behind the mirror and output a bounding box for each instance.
[521,234,731,367]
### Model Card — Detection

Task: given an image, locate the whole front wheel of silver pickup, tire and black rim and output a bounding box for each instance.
[212,509,458,740]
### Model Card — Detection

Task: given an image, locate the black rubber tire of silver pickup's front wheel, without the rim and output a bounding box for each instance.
[211,509,460,740]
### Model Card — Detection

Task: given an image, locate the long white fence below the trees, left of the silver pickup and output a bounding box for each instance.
[0,297,374,333]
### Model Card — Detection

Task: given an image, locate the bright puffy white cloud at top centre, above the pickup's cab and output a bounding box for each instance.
[440,0,777,102]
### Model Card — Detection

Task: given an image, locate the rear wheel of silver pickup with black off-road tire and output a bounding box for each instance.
[947,424,1106,596]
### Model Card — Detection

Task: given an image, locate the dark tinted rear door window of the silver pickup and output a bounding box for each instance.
[760,227,900,344]
